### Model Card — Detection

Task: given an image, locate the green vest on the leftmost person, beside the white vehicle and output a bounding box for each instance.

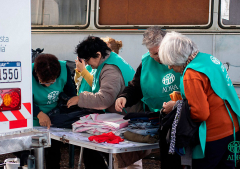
[32,61,67,126]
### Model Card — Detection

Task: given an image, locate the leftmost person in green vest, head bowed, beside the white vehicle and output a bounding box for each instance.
[32,54,76,169]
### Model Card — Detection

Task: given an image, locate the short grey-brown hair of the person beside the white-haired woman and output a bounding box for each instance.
[142,26,166,49]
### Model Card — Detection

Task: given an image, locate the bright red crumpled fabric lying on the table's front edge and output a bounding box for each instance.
[88,132,124,144]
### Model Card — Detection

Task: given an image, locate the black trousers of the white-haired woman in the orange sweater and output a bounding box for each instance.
[193,132,240,169]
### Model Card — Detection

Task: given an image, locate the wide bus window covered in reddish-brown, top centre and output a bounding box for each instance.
[95,0,212,28]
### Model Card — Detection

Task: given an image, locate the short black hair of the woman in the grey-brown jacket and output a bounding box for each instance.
[75,36,111,60]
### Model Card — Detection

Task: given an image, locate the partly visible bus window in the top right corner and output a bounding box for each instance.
[220,0,240,28]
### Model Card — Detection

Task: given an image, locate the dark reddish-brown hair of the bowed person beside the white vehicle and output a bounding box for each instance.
[34,53,61,82]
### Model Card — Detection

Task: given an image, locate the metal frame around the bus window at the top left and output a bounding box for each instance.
[31,0,91,30]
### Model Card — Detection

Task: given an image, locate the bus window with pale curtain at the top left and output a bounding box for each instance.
[31,0,89,28]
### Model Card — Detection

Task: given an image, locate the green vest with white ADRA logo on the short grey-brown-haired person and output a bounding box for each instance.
[140,52,181,112]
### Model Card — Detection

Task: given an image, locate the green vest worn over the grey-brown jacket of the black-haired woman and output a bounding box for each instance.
[92,52,135,93]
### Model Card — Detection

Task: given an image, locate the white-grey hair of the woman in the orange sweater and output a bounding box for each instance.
[158,32,198,66]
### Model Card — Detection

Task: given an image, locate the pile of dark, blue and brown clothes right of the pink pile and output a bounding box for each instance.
[123,112,159,143]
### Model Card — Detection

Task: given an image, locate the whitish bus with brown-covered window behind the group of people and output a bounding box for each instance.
[31,0,240,96]
